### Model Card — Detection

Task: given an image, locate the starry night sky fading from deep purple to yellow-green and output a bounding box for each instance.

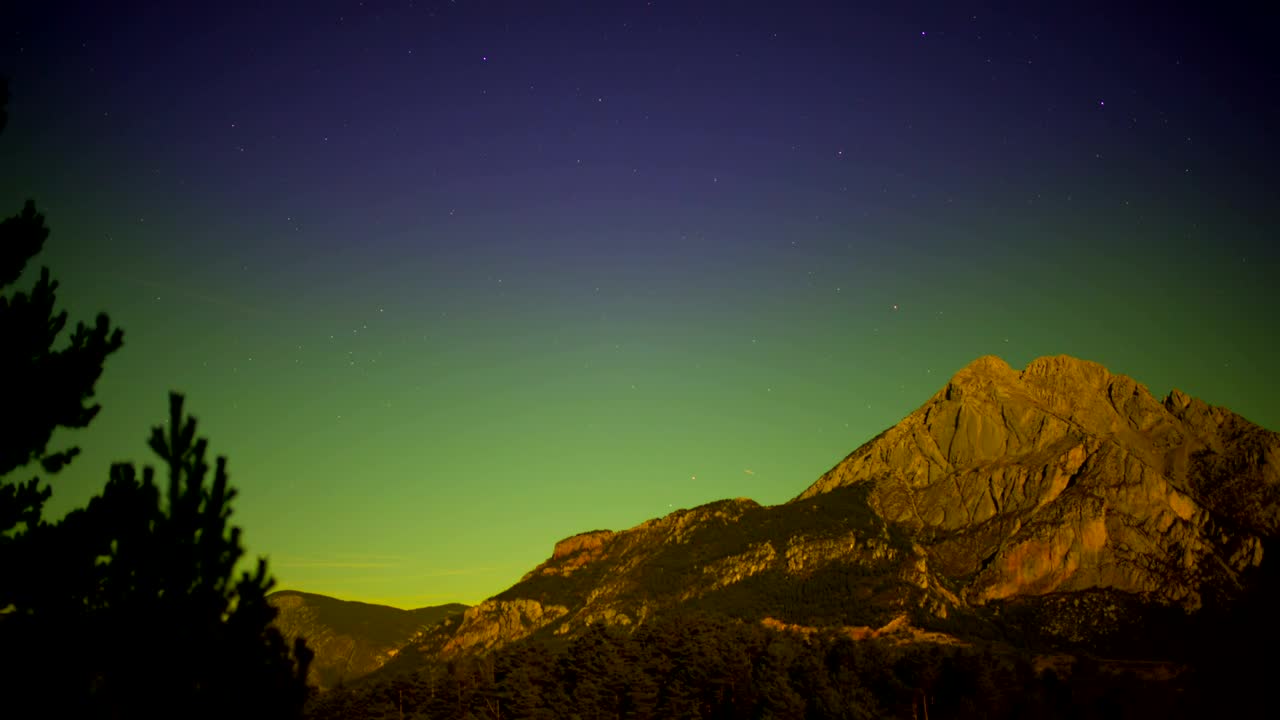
[0,0,1280,607]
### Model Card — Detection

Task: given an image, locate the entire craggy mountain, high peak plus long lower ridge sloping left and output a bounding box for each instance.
[383,356,1280,674]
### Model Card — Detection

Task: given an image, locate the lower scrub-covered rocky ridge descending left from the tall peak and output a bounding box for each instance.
[409,492,959,657]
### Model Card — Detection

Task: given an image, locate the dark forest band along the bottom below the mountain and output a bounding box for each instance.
[308,607,1196,720]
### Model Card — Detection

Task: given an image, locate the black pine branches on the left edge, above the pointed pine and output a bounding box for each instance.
[0,77,123,543]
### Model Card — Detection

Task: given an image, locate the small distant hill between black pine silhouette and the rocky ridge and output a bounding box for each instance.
[268,591,467,689]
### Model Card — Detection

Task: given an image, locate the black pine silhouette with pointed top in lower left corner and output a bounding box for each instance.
[0,393,312,719]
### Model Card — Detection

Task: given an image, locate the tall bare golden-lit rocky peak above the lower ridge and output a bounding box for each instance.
[800,356,1280,607]
